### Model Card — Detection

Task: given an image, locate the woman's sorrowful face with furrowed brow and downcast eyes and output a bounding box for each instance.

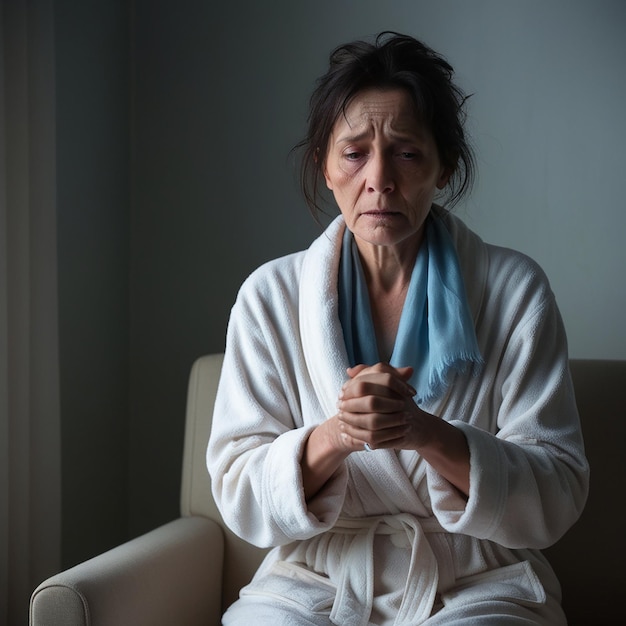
[324,89,449,254]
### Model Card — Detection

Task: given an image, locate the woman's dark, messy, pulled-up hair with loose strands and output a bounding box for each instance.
[296,31,475,216]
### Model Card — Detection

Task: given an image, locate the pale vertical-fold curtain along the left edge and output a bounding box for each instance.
[0,0,61,626]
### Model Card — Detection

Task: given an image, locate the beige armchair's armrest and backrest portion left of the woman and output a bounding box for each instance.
[30,354,263,626]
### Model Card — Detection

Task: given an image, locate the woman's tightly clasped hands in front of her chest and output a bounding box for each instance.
[337,363,428,451]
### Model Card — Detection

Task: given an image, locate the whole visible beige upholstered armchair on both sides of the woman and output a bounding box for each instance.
[30,355,626,626]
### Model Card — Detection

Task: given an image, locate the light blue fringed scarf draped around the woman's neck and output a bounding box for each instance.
[338,212,483,404]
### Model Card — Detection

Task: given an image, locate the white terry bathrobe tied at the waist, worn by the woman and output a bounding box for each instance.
[207,211,588,626]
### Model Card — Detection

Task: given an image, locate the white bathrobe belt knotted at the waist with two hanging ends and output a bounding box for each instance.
[330,513,438,626]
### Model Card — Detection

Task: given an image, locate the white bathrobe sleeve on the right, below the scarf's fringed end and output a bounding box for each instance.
[429,253,589,548]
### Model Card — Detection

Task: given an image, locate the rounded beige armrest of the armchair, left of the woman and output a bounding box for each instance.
[30,517,224,626]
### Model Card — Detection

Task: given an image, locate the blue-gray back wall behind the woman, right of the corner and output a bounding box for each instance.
[54,0,626,552]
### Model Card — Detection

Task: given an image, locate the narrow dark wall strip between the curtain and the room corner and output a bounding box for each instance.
[54,0,130,566]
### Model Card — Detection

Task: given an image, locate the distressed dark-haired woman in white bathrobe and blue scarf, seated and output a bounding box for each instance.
[207,33,588,626]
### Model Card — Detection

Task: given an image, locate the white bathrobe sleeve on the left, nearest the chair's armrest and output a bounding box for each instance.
[207,255,347,547]
